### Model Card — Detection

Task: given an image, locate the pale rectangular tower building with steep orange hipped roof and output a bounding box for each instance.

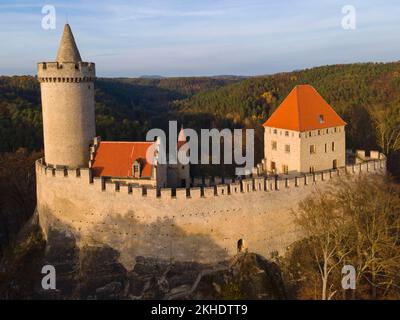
[264,85,346,174]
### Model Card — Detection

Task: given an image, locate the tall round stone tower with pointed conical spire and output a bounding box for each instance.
[38,24,96,168]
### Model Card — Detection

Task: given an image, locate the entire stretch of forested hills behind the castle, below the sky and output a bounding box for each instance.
[0,62,400,170]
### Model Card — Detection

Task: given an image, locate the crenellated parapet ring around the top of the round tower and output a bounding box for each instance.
[37,62,96,83]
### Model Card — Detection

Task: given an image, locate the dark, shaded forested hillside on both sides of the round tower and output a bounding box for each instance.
[0,76,241,153]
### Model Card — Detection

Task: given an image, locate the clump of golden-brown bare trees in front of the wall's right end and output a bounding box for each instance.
[295,176,400,299]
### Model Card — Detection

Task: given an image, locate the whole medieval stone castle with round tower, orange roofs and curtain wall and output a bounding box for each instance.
[36,24,386,268]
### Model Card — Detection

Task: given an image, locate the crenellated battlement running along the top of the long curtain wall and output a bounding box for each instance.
[36,151,386,200]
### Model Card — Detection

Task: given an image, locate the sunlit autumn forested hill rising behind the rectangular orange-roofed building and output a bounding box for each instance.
[174,62,400,154]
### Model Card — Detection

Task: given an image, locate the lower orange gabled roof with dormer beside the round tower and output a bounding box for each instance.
[92,141,154,178]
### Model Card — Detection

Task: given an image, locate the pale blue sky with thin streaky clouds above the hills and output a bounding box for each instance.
[0,0,400,77]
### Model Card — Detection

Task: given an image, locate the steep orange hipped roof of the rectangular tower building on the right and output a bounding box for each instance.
[263,85,346,131]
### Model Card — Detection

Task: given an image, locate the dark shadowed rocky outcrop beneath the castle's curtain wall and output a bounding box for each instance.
[2,216,286,300]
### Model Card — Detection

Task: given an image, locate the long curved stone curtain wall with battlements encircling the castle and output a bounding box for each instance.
[36,154,386,268]
